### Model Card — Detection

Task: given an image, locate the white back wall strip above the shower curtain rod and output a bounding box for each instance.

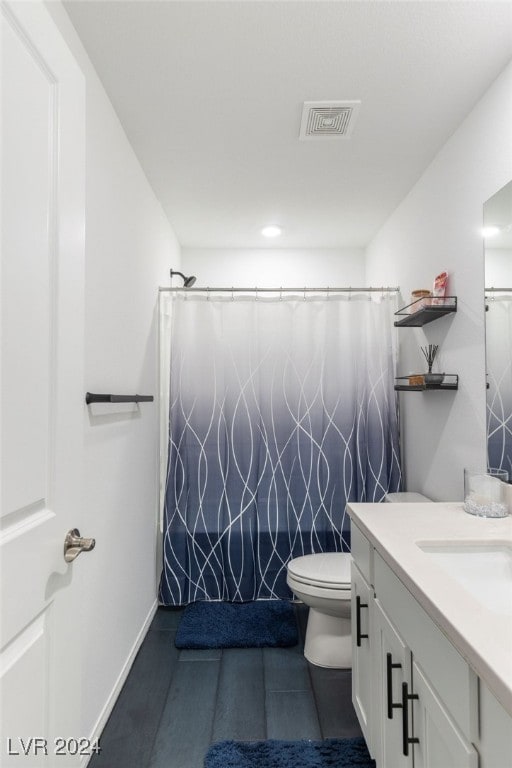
[182,247,365,288]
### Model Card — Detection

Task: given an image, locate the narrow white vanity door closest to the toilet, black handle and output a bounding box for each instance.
[351,561,374,756]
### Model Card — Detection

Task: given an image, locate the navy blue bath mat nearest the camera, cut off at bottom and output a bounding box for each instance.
[204,738,375,768]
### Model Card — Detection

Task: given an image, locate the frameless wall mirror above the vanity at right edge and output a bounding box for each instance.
[483,181,512,481]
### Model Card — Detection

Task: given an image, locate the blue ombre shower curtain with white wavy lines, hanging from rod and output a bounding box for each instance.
[160,293,401,605]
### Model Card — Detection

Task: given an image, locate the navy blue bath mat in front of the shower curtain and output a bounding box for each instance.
[175,600,298,649]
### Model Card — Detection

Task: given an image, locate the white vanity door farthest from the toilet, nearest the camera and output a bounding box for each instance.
[412,661,478,768]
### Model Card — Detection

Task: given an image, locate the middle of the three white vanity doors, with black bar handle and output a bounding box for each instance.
[372,599,412,768]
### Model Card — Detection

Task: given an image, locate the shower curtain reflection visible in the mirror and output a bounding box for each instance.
[485,294,512,472]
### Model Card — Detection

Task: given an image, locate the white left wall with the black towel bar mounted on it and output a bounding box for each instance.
[47,2,180,736]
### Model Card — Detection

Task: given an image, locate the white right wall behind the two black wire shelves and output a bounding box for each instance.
[366,64,512,500]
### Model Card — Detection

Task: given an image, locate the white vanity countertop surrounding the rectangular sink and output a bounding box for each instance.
[348,502,512,714]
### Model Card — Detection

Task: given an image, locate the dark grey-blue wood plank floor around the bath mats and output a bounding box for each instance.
[89,606,361,768]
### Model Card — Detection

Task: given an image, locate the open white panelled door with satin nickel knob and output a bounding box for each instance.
[0,2,87,768]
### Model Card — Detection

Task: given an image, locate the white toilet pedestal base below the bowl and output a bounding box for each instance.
[304,608,352,669]
